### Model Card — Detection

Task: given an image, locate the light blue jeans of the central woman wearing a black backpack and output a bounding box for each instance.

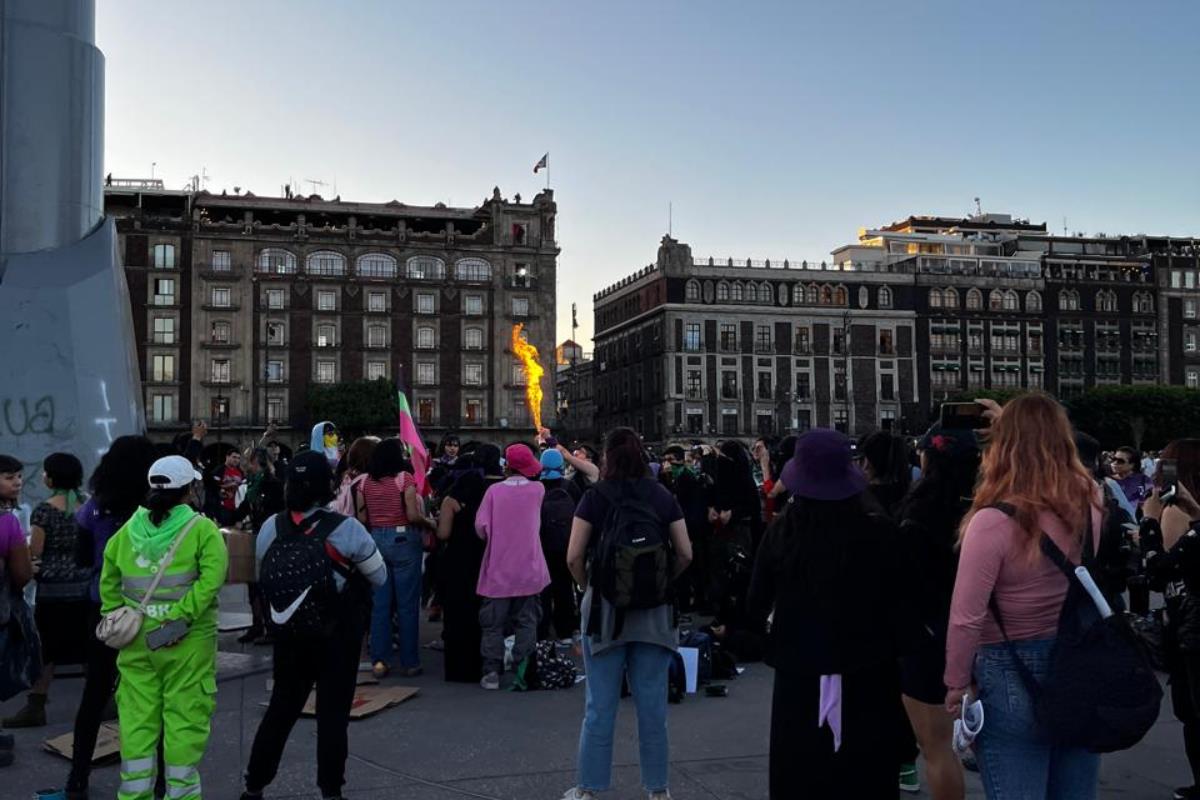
[577,636,672,792]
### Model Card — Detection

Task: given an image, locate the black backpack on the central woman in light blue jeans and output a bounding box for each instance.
[587,481,674,639]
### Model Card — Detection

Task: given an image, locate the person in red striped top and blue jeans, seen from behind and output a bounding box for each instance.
[356,439,436,678]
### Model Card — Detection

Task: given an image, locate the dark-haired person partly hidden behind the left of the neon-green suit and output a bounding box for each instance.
[66,437,157,800]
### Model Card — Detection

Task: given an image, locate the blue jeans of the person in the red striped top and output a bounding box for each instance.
[370,527,424,669]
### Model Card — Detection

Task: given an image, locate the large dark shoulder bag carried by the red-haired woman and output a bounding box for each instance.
[989,505,1163,753]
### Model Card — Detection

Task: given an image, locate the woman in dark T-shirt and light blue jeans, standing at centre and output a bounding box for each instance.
[564,428,691,800]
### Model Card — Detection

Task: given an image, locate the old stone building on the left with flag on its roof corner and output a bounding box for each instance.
[106,185,558,438]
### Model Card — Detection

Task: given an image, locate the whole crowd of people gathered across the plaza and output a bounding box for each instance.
[0,393,1185,800]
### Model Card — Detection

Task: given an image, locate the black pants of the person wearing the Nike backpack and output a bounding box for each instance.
[246,624,365,798]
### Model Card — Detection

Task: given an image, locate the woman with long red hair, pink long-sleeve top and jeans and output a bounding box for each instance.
[943,392,1103,800]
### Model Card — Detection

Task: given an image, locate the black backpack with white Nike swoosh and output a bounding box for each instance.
[258,511,353,638]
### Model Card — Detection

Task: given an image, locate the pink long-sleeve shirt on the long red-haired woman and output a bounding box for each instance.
[943,489,1103,688]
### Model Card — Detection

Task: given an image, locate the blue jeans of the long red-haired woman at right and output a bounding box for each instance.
[974,639,1100,800]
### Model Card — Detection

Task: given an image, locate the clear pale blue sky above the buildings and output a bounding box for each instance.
[97,0,1200,349]
